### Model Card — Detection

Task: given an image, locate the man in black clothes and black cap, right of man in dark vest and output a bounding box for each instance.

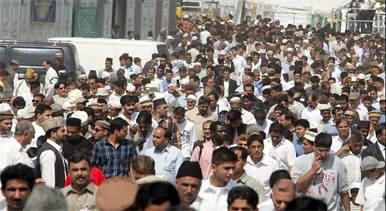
[62,117,93,160]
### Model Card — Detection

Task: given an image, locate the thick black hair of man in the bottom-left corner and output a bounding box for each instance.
[0,163,36,190]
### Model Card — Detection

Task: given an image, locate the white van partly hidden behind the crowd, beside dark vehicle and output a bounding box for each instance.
[48,37,167,74]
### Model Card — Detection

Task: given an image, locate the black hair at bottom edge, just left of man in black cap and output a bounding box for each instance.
[134,182,180,210]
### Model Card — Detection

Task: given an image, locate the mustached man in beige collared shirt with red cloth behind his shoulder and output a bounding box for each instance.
[62,152,96,210]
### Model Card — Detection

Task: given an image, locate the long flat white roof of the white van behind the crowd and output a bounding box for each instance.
[48,37,165,45]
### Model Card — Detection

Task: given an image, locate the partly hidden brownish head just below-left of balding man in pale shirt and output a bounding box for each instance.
[129,155,155,180]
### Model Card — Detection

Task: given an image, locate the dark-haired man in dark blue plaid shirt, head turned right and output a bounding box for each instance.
[91,117,137,178]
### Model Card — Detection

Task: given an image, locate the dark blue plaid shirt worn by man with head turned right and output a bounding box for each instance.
[91,139,137,178]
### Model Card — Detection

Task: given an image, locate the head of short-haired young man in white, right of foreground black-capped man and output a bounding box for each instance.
[210,147,237,187]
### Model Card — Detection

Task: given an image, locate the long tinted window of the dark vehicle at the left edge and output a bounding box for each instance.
[10,47,63,67]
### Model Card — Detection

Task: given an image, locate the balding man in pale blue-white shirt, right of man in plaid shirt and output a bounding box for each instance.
[142,127,184,184]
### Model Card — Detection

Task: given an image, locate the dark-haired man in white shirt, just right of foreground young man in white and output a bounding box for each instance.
[244,134,279,201]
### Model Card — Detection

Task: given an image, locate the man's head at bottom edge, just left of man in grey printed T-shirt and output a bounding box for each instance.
[271,179,296,211]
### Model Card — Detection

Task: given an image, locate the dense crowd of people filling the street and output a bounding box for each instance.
[0,12,386,211]
